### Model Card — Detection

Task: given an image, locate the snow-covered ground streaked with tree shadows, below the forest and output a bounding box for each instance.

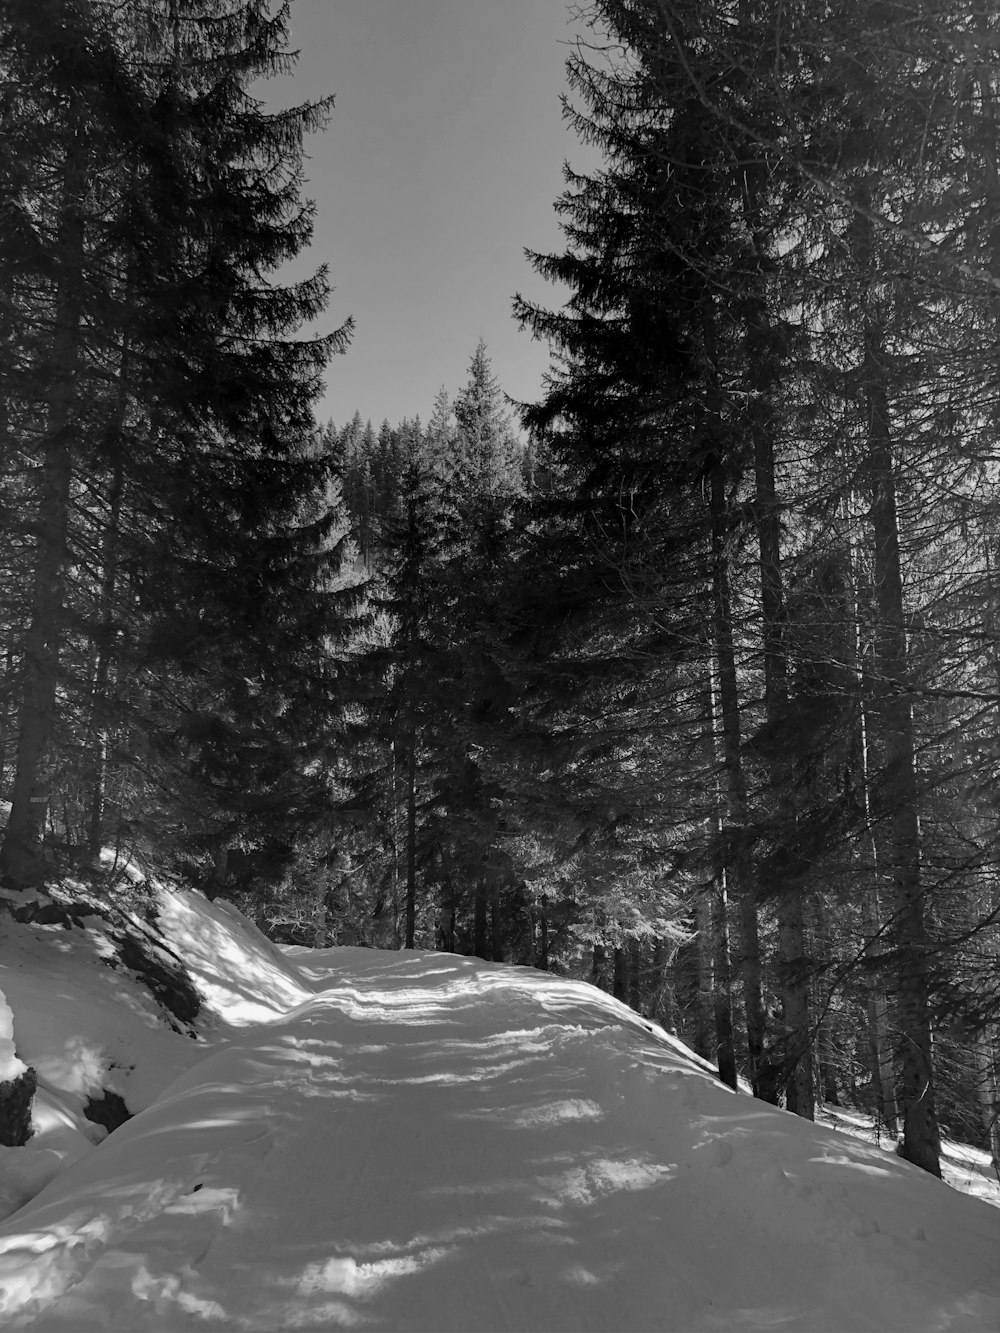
[0,890,1000,1333]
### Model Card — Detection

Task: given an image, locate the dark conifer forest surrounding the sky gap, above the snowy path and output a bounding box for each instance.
[9,0,1000,1199]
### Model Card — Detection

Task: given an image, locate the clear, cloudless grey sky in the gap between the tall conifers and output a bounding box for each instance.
[268,0,583,425]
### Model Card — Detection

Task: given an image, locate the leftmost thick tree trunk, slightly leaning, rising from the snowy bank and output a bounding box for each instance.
[0,122,87,888]
